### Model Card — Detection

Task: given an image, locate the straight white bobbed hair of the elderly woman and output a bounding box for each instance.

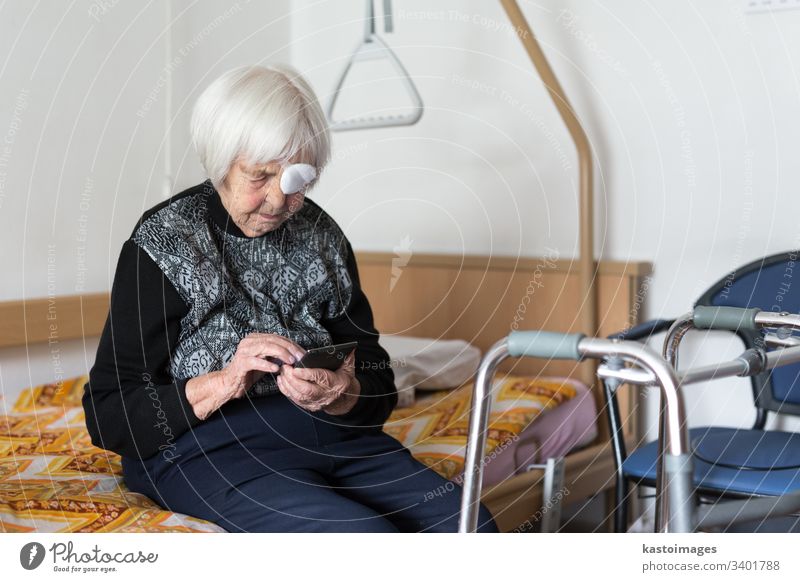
[191,66,330,189]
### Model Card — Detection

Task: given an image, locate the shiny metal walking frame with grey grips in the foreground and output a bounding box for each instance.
[459,306,800,533]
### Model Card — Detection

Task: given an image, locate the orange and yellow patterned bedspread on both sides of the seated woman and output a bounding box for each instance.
[0,376,575,532]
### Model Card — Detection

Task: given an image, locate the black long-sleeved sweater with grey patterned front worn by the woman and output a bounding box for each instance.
[83,181,397,459]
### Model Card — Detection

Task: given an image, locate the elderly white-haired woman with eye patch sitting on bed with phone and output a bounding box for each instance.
[83,67,496,532]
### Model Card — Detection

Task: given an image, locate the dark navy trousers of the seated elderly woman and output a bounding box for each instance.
[122,394,497,532]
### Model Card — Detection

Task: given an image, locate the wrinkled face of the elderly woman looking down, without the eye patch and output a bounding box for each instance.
[219,160,305,237]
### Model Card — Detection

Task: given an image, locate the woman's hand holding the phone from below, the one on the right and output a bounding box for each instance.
[277,350,361,415]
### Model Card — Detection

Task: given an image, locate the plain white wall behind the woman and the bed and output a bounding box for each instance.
[0,0,800,438]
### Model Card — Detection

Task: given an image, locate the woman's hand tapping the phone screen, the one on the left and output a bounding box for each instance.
[186,333,305,420]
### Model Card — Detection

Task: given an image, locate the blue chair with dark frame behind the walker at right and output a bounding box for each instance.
[604,251,800,532]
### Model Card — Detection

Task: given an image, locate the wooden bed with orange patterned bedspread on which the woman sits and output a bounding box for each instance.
[0,253,649,532]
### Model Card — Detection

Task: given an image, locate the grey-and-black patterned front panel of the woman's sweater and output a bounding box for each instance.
[132,181,352,396]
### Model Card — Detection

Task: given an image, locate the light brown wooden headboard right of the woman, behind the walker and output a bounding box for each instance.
[358,253,650,375]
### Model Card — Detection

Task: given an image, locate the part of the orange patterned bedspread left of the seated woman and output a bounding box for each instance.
[0,376,222,533]
